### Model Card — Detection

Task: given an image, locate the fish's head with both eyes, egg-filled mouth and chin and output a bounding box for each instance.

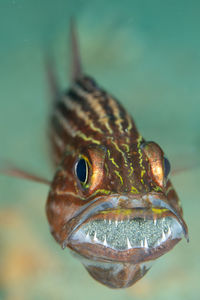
[46,138,188,288]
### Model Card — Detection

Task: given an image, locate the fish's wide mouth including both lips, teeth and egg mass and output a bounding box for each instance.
[63,194,188,264]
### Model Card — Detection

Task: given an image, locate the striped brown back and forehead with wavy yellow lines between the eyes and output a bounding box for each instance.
[51,76,154,193]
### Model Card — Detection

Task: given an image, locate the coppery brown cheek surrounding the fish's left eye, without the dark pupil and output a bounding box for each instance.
[46,147,105,244]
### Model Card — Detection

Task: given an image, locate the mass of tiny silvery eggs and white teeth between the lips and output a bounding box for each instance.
[72,217,183,251]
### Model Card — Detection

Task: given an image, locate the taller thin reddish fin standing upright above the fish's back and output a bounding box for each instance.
[70,18,82,81]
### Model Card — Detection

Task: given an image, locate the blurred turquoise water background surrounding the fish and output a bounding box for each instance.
[0,0,200,300]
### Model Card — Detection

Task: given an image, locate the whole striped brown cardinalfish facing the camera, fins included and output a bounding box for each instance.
[2,21,188,288]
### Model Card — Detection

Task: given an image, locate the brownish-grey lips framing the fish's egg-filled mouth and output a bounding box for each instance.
[62,193,188,263]
